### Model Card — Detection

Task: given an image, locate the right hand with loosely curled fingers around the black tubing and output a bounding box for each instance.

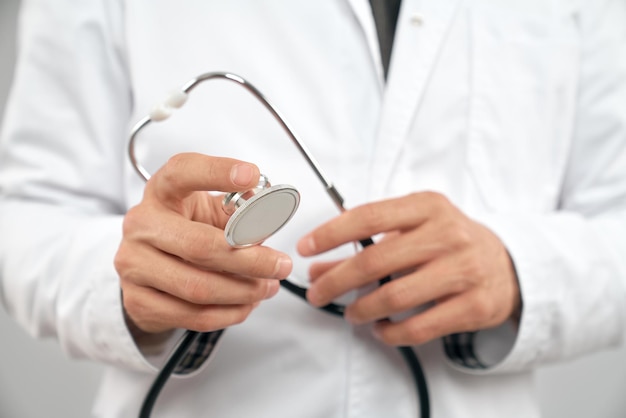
[298,192,521,345]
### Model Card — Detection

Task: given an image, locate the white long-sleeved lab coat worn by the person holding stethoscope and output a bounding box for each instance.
[0,0,626,418]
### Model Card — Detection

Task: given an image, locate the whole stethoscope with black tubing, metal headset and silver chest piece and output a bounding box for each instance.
[128,72,430,418]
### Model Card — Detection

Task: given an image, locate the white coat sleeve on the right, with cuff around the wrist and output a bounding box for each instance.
[452,0,626,373]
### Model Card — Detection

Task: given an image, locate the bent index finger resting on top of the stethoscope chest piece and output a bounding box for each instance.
[146,153,260,204]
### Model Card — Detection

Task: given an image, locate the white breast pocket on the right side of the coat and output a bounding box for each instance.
[467,1,579,211]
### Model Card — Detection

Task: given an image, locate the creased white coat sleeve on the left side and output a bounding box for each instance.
[0,0,151,370]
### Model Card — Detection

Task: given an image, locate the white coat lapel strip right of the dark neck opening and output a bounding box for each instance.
[370,0,460,199]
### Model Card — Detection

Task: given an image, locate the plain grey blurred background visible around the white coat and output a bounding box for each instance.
[0,0,626,418]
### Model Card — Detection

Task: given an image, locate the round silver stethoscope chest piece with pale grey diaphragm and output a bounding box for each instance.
[223,175,300,248]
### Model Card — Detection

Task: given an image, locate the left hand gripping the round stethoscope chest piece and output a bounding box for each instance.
[115,154,291,333]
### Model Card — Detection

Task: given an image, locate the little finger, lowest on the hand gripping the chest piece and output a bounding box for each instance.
[123,285,258,333]
